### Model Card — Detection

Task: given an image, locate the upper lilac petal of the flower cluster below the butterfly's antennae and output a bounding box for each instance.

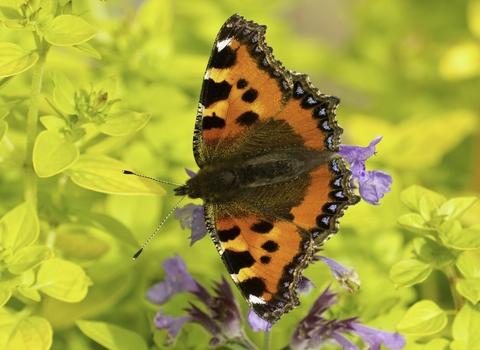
[147,255,201,304]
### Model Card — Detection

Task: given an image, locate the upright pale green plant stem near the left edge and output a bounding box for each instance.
[24,33,50,210]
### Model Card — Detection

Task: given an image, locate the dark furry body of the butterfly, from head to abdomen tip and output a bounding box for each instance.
[175,147,334,203]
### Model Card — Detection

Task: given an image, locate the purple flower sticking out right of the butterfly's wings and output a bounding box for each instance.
[338,136,392,205]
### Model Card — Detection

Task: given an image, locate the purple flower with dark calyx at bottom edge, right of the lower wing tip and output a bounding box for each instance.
[290,288,405,350]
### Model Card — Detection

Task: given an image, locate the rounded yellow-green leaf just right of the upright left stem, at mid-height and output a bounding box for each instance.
[33,130,80,177]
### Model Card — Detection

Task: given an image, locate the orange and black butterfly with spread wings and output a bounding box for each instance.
[175,15,359,323]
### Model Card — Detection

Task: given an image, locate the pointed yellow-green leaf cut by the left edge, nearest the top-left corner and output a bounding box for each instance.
[0,42,38,77]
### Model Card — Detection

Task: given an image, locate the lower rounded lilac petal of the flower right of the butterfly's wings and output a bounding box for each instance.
[358,170,392,205]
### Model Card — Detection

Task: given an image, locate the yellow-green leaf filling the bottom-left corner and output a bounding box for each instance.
[0,309,53,350]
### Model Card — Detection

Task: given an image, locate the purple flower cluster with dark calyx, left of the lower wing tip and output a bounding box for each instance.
[147,255,248,346]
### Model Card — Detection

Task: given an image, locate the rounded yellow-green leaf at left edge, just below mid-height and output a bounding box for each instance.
[0,203,40,252]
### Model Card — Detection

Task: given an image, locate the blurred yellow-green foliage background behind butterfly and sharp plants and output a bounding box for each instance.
[0,0,480,349]
